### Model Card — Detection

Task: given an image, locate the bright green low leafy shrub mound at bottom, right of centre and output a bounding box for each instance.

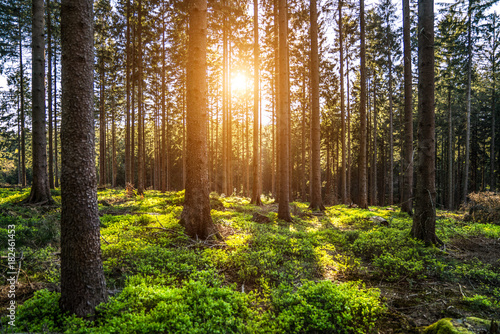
[259,281,384,334]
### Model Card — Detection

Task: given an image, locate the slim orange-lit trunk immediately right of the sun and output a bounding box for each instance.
[252,0,262,205]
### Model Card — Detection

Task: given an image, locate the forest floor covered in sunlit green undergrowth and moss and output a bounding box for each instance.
[0,188,500,333]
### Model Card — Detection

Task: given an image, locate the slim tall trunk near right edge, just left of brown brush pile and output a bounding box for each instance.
[462,8,472,204]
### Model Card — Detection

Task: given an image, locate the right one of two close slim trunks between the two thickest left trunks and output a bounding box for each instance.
[137,0,146,195]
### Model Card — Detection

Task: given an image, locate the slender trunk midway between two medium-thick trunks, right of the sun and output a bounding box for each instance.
[339,0,347,204]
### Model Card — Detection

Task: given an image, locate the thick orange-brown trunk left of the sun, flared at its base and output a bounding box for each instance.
[181,0,217,239]
